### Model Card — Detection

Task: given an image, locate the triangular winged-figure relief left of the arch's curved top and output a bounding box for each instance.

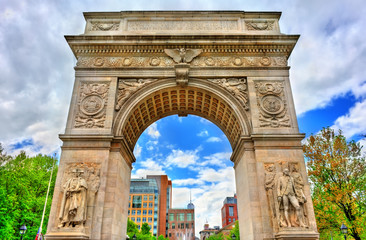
[115,78,158,111]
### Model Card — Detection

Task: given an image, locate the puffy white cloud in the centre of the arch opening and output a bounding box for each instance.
[167,149,199,168]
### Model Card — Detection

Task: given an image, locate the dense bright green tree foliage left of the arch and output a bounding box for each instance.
[0,145,57,240]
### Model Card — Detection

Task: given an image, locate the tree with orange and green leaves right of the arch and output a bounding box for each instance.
[304,127,366,240]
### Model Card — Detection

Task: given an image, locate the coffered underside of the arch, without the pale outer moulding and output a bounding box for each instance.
[116,86,249,149]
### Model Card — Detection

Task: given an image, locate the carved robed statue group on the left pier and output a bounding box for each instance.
[58,163,100,231]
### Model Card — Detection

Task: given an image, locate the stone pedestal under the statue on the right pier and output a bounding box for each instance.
[275,228,319,240]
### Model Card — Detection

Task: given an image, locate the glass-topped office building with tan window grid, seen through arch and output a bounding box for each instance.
[128,179,159,236]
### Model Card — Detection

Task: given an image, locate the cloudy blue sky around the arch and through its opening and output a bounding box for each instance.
[0,0,366,236]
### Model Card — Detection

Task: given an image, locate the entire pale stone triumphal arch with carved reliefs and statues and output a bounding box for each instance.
[46,11,318,240]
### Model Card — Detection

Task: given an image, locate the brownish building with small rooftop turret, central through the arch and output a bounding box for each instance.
[168,202,195,240]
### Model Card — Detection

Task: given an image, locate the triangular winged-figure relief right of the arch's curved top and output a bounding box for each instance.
[207,78,249,111]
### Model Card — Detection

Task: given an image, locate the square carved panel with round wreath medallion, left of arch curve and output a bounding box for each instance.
[74,82,109,128]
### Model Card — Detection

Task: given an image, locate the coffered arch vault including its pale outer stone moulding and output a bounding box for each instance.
[113,78,251,150]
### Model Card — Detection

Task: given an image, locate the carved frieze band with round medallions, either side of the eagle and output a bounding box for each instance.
[76,56,287,68]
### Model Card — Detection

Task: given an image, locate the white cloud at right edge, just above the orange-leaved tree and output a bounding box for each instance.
[332,100,366,138]
